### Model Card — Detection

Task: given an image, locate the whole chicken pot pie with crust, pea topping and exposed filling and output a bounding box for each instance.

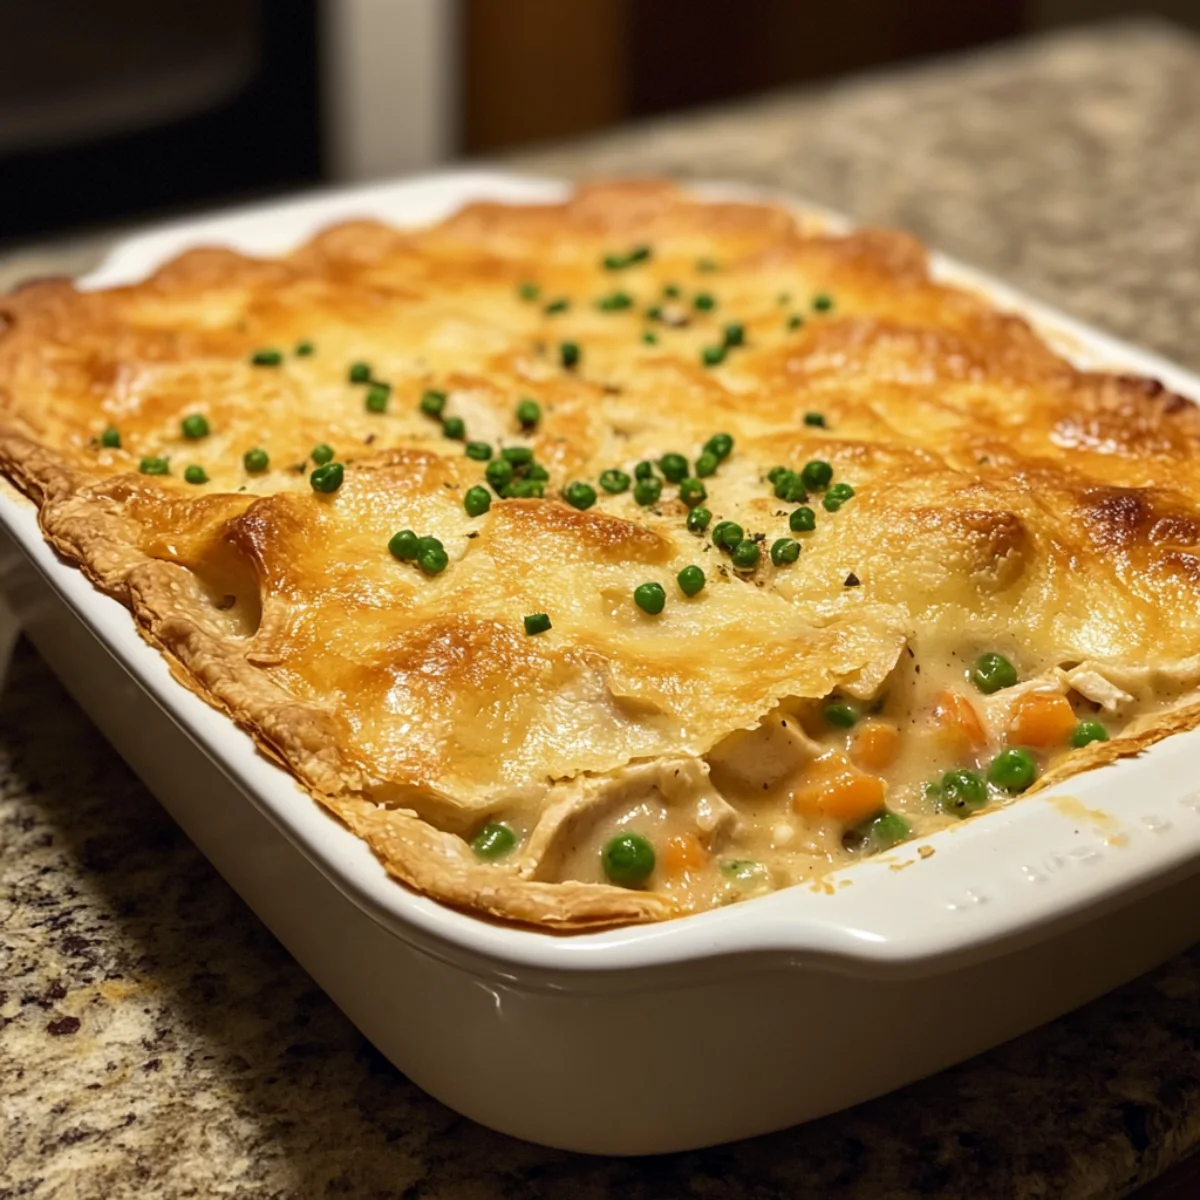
[0,182,1200,929]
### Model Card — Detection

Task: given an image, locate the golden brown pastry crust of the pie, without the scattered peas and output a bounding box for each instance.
[0,182,1200,929]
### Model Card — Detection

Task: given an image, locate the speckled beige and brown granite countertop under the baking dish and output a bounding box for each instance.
[0,25,1200,1200]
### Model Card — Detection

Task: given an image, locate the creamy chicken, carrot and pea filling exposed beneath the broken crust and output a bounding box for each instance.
[472,647,1190,910]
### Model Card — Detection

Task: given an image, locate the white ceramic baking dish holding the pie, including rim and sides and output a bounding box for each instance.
[0,172,1200,1153]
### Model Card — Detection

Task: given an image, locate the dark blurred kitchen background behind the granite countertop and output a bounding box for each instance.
[0,0,1200,245]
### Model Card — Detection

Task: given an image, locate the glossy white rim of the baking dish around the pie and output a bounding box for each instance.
[9,169,1200,986]
